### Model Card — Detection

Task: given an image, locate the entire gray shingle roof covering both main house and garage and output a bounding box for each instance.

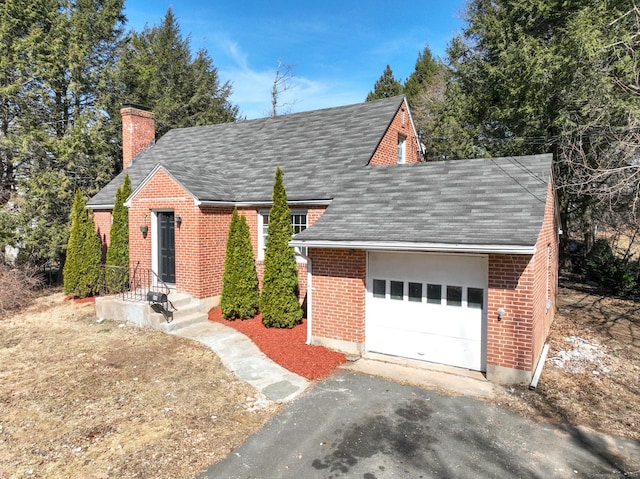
[88,97,552,249]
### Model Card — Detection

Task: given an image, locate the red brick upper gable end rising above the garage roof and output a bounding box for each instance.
[369,102,420,166]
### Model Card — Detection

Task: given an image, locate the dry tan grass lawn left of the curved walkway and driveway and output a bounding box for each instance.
[0,294,277,479]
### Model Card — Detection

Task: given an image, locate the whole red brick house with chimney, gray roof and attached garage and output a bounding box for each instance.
[88,97,558,383]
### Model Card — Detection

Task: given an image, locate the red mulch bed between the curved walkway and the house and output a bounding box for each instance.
[209,308,346,379]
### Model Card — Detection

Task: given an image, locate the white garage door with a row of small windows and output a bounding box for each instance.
[365,252,487,371]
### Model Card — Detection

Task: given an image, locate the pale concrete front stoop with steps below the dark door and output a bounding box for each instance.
[96,292,208,332]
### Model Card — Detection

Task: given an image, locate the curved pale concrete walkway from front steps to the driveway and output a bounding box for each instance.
[171,321,309,402]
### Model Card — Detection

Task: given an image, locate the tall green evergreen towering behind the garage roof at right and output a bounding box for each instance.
[435,0,640,255]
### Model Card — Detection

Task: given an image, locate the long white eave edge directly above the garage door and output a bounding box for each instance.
[289,239,536,255]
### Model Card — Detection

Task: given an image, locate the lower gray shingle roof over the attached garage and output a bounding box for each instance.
[294,155,552,251]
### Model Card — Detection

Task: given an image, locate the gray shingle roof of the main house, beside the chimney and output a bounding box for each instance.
[88,96,403,208]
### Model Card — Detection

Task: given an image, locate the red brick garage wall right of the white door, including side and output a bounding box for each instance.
[487,178,558,371]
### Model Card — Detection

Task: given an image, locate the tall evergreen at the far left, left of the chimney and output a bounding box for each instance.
[7,0,124,263]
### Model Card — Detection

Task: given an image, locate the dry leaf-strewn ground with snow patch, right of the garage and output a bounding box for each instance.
[500,280,640,441]
